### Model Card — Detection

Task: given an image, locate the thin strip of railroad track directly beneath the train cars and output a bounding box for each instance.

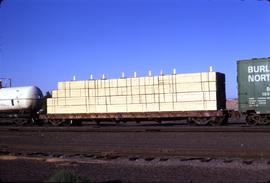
[0,125,270,133]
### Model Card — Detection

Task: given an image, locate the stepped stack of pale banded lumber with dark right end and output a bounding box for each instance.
[47,72,226,114]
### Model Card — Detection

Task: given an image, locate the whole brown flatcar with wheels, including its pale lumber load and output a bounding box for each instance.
[40,71,228,125]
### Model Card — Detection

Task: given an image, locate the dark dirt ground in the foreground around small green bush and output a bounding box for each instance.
[0,156,270,182]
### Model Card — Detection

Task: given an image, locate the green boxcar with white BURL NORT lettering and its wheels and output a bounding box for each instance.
[237,57,270,124]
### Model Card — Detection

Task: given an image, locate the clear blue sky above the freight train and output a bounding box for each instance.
[0,0,270,98]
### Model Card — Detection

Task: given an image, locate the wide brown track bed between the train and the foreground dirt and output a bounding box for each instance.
[0,125,270,159]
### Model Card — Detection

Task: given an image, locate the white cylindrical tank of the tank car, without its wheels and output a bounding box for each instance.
[0,86,43,113]
